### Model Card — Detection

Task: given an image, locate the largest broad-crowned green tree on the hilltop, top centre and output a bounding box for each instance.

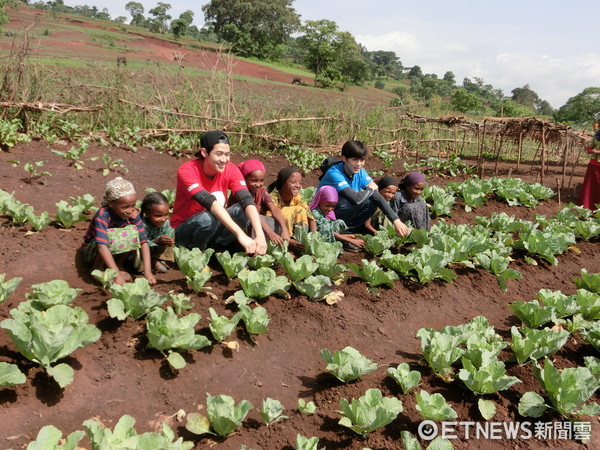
[202,0,300,59]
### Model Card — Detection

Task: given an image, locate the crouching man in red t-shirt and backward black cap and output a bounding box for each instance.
[171,131,267,255]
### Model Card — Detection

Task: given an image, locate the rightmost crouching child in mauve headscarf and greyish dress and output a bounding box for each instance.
[390,172,431,231]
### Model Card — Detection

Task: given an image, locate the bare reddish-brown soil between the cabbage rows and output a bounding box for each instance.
[0,141,600,449]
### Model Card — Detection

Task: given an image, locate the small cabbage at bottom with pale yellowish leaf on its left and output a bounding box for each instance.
[185,393,253,436]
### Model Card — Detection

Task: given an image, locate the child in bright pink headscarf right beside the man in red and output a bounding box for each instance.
[228,159,290,246]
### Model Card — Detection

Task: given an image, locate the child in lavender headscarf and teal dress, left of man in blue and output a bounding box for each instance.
[310,186,365,251]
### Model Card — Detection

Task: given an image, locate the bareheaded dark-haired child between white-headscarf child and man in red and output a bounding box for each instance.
[142,192,175,273]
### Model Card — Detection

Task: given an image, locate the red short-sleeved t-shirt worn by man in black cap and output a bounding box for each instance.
[171,159,247,228]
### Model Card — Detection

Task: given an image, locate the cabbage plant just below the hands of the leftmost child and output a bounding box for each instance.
[106,278,169,320]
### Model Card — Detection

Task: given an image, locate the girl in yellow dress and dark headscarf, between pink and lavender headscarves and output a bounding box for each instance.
[267,167,317,252]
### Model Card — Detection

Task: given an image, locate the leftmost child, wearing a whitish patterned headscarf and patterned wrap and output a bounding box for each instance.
[84,177,156,285]
